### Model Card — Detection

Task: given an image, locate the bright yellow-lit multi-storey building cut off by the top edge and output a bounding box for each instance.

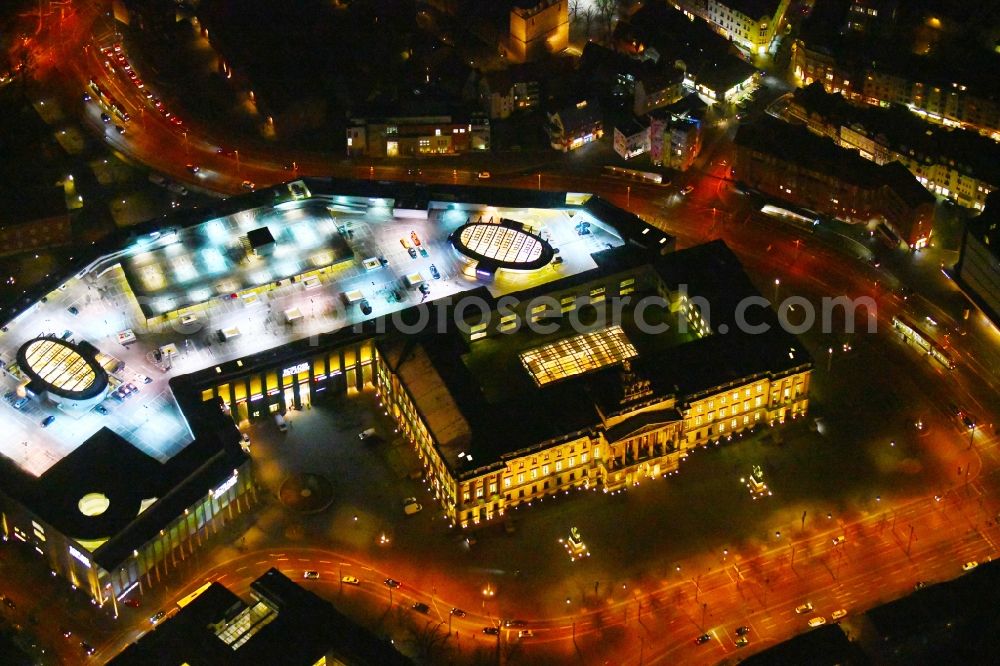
[671,0,789,54]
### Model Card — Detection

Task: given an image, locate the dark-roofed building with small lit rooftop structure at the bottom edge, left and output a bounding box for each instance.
[108,568,413,666]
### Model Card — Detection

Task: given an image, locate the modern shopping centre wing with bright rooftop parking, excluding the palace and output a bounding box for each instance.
[0,180,673,605]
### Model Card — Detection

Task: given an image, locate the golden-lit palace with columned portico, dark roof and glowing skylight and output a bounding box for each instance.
[375,243,812,527]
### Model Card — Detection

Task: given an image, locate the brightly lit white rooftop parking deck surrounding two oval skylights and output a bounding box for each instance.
[0,193,624,476]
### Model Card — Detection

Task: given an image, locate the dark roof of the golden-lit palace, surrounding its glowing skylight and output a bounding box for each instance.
[379,241,811,475]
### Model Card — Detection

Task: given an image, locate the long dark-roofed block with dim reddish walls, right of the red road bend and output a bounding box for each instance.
[733,116,934,249]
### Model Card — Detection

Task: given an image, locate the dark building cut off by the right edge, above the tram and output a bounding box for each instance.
[951,192,1000,328]
